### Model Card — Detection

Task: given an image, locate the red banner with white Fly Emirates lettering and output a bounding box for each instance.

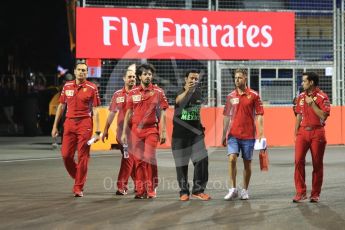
[76,8,295,60]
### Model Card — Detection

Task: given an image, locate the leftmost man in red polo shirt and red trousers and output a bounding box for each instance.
[52,62,101,197]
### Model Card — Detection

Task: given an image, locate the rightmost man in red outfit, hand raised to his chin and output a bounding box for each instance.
[293,72,331,203]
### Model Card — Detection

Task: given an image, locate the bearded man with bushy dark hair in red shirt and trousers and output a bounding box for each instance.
[121,64,169,199]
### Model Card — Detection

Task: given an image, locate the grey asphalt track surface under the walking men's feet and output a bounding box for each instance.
[0,137,345,230]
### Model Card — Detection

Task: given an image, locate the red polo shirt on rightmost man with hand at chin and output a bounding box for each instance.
[296,88,331,127]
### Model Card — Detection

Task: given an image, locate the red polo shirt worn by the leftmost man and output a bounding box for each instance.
[59,81,101,118]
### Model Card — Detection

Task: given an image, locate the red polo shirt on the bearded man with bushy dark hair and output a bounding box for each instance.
[127,84,169,127]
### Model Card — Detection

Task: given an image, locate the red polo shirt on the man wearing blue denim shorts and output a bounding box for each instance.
[223,88,264,139]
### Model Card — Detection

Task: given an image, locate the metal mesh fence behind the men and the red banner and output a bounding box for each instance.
[80,0,345,106]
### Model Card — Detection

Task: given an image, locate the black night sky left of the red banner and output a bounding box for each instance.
[0,0,72,73]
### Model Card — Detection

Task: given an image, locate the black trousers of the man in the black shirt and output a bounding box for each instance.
[172,134,208,195]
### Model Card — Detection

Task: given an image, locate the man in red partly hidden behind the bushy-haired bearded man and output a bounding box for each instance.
[102,64,136,195]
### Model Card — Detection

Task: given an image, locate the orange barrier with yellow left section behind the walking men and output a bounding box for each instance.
[91,106,345,150]
